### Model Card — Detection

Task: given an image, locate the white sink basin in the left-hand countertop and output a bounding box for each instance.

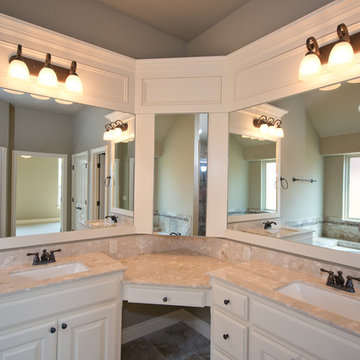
[10,262,89,280]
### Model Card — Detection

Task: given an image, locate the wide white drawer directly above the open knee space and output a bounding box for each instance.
[124,285,205,307]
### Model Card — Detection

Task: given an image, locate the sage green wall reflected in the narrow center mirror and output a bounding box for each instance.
[154,114,194,215]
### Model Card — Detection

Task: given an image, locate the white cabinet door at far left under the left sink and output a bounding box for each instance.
[0,322,57,360]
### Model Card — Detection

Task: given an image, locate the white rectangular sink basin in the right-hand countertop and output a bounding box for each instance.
[276,281,360,321]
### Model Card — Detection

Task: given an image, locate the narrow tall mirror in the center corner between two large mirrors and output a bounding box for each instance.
[153,114,208,236]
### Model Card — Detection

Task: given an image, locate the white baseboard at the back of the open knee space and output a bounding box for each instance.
[122,309,210,344]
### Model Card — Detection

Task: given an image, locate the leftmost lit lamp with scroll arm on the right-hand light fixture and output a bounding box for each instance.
[299,36,321,80]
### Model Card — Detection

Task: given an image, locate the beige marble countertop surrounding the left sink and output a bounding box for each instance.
[0,253,126,296]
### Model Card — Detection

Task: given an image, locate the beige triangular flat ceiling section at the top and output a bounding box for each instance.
[96,0,249,42]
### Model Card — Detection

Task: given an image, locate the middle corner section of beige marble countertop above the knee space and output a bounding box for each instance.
[121,250,229,289]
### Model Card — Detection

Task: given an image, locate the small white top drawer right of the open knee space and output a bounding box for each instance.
[213,284,249,321]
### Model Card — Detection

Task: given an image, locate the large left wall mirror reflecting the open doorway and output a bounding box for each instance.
[0,89,135,237]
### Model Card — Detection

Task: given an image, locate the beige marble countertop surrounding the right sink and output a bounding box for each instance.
[209,261,360,336]
